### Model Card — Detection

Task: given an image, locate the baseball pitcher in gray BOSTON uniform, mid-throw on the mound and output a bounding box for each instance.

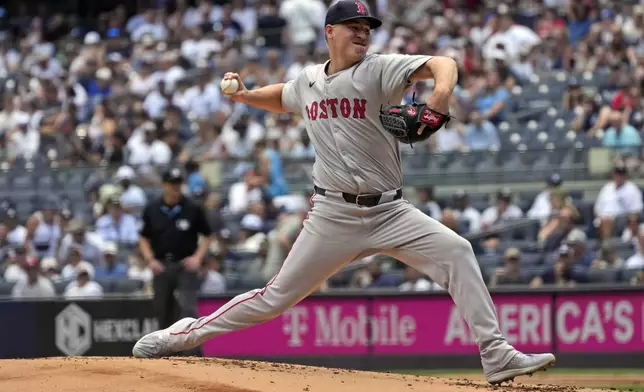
[133,0,555,384]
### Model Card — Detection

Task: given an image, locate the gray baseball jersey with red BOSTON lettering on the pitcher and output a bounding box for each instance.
[282,54,431,194]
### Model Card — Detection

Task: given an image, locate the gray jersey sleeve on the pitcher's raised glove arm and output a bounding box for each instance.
[380,54,432,104]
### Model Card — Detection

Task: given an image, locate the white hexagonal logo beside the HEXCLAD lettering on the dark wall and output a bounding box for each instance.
[56,304,92,355]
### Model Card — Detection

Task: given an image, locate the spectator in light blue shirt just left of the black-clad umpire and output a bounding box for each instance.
[95,195,139,247]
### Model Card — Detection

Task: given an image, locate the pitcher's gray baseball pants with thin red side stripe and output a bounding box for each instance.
[162,191,515,371]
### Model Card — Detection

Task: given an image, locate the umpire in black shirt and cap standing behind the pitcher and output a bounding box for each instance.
[139,168,212,344]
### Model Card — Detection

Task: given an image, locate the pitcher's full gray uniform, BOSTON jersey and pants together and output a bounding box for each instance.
[145,55,528,374]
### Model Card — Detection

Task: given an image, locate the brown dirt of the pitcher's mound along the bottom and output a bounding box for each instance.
[0,357,624,392]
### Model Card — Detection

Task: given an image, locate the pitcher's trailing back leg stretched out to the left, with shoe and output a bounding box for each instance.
[132,196,365,358]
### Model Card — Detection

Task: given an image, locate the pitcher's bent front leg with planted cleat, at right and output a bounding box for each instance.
[371,200,554,383]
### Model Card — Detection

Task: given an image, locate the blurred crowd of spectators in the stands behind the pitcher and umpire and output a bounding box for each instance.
[0,0,644,298]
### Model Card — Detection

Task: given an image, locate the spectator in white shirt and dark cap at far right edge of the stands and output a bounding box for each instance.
[595,162,643,240]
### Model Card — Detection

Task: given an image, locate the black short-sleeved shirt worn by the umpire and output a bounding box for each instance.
[141,197,212,263]
